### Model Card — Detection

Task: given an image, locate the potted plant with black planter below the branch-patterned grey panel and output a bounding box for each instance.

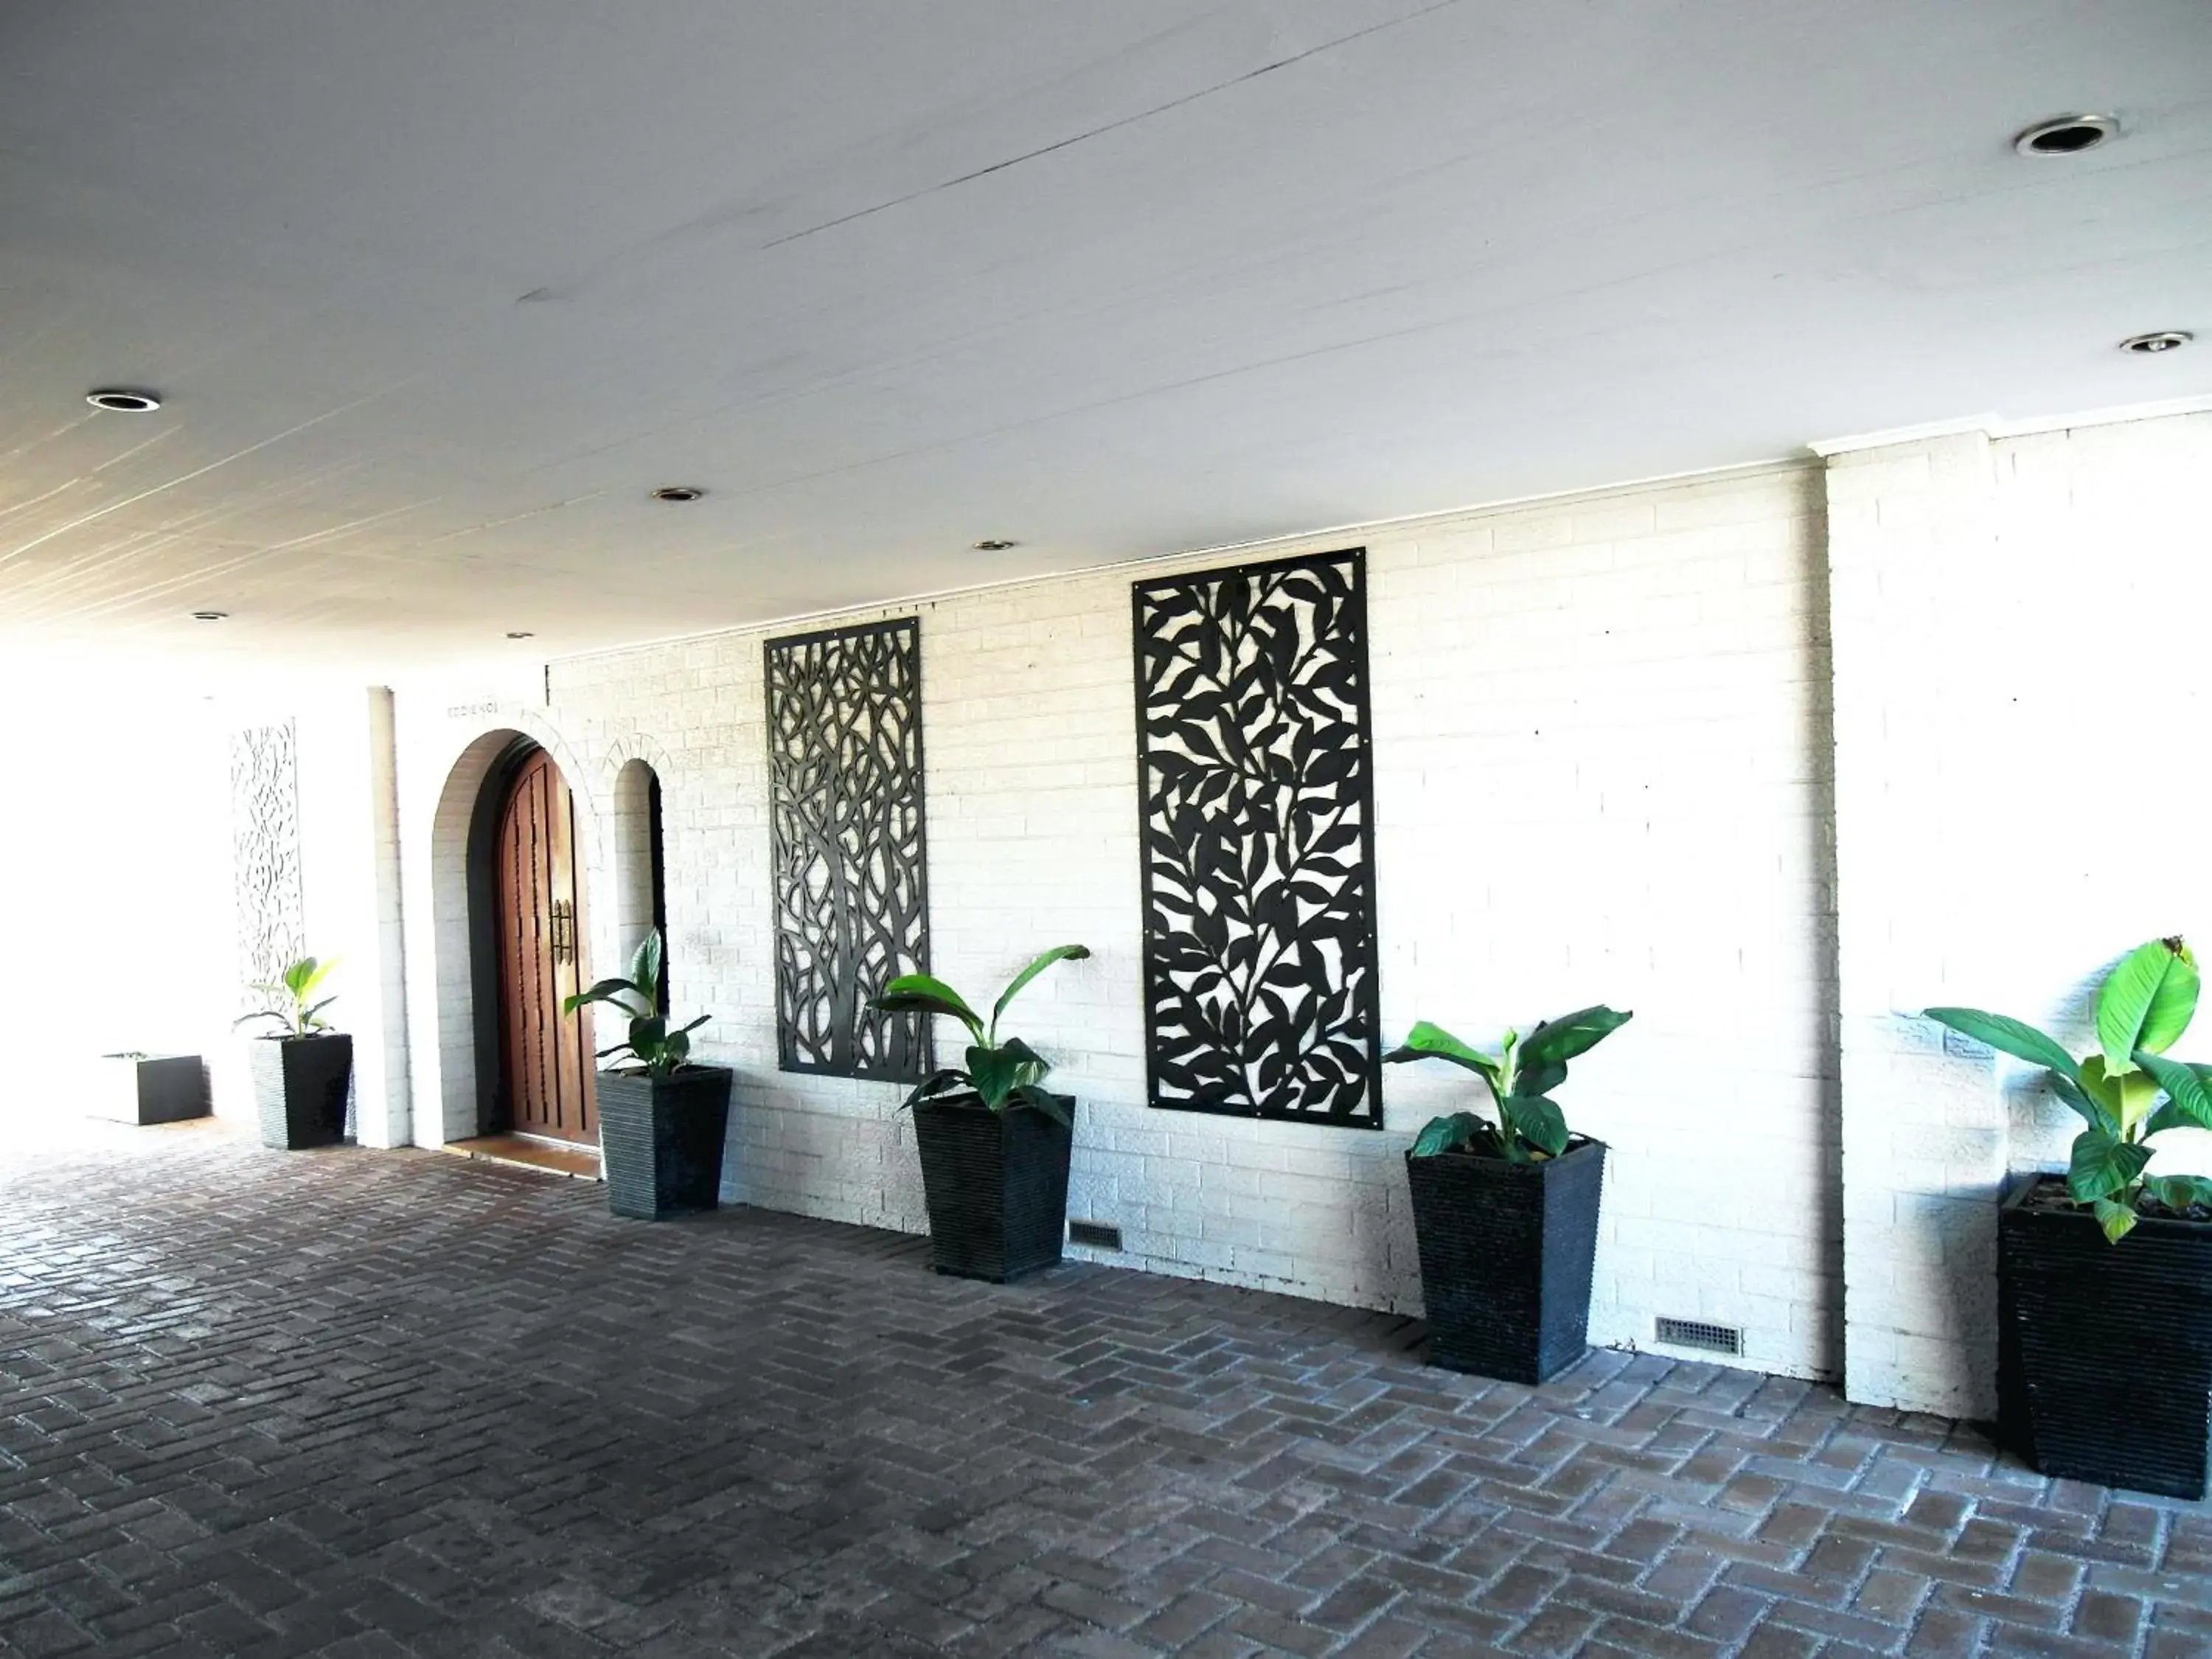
[874,945,1091,1285]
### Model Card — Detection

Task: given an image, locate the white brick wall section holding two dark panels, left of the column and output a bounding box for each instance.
[400,467,1838,1374]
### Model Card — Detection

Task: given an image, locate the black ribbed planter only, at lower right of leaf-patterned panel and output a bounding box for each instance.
[1405,1139,1606,1382]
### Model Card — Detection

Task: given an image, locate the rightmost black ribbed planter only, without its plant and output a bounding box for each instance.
[1997,1175,2212,1498]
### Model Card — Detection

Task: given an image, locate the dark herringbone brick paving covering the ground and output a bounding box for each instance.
[0,1126,2212,1659]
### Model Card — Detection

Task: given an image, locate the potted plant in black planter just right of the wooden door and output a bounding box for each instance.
[562,929,730,1221]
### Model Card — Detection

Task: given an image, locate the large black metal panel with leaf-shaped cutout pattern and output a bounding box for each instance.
[1133,549,1382,1128]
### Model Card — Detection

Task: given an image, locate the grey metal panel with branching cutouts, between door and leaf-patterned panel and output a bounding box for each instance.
[768,617,933,1082]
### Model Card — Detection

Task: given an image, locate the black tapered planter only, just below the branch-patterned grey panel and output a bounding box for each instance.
[914,1095,1075,1285]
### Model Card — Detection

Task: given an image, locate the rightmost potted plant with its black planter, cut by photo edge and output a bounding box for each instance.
[1927,938,2212,1498]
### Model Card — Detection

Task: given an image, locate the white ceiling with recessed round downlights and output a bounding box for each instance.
[0,0,2212,666]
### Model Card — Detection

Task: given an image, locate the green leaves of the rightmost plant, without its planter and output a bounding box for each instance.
[1927,938,2212,1243]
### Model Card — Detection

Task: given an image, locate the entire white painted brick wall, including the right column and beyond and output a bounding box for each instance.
[195,403,2212,1413]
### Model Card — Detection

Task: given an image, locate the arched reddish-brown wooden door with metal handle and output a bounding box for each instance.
[498,750,599,1144]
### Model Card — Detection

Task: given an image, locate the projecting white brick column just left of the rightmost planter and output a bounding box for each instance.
[1827,431,2006,1416]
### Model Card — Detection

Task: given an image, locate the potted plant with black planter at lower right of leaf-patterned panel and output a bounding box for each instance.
[1382,1006,1630,1382]
